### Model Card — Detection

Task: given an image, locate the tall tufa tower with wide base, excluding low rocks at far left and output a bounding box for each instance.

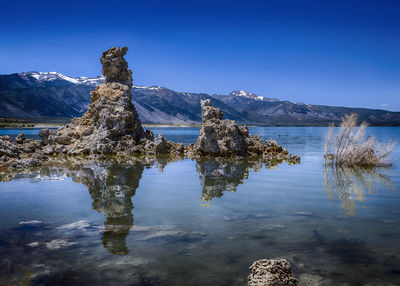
[40,47,153,155]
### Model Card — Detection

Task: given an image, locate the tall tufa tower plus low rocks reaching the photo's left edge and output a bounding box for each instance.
[0,47,156,168]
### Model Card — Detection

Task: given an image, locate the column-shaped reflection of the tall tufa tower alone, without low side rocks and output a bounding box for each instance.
[77,162,144,254]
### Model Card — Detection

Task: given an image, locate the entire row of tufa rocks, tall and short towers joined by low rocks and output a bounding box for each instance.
[0,47,300,169]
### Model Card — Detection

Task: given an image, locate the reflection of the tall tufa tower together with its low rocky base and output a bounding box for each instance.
[38,158,182,255]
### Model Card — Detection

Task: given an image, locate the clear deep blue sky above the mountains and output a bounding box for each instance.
[0,0,400,111]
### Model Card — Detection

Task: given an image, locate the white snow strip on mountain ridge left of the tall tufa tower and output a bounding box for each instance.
[19,71,104,86]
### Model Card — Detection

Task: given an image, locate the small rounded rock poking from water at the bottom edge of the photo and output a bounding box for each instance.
[247,259,299,286]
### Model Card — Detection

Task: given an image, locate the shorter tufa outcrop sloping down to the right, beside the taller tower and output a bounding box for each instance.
[189,99,300,163]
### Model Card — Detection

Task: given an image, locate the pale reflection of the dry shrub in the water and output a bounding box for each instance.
[324,165,396,216]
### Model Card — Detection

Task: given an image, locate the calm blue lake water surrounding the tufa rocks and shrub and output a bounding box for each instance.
[0,127,400,285]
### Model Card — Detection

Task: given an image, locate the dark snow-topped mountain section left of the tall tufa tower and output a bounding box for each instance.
[0,71,104,118]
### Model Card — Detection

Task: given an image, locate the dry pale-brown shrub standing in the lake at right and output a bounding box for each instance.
[324,113,395,167]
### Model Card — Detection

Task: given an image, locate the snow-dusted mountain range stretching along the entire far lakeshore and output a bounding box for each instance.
[0,72,400,126]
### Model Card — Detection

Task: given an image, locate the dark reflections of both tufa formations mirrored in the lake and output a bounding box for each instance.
[1,154,296,252]
